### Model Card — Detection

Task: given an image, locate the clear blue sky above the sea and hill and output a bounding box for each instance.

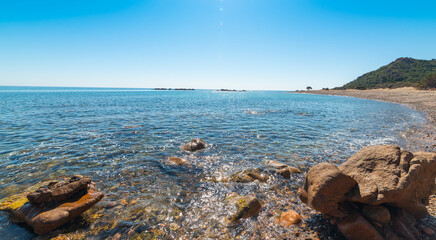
[0,0,436,90]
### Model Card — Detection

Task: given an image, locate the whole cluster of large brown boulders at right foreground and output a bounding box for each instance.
[299,145,436,240]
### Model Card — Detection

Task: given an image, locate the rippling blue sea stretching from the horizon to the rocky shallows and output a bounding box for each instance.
[0,87,425,239]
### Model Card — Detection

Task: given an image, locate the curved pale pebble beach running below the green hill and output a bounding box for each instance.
[296,87,436,218]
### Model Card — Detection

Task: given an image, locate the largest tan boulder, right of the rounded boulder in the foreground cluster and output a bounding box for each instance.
[338,145,436,218]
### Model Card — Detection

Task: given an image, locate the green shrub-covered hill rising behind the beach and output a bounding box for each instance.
[342,58,436,89]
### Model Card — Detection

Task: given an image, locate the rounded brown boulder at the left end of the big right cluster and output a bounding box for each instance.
[298,163,356,217]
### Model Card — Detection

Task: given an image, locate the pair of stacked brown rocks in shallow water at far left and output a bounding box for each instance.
[4,175,104,234]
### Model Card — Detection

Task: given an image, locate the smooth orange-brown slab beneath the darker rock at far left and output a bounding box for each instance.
[11,187,104,234]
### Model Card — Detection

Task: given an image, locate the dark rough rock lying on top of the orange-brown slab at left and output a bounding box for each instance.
[27,175,92,205]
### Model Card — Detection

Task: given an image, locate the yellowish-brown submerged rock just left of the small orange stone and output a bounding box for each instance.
[228,195,262,223]
